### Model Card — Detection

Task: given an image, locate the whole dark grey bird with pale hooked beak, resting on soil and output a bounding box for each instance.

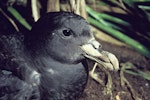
[0,12,118,100]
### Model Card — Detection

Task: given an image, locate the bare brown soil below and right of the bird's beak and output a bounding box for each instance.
[79,41,150,100]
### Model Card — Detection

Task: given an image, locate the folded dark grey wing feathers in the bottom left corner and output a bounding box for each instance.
[0,70,40,100]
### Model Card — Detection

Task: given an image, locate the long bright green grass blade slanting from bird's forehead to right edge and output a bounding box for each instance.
[88,17,150,58]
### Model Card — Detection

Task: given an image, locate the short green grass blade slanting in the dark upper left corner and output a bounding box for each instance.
[7,7,31,30]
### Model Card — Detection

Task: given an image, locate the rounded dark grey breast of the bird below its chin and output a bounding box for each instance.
[40,63,88,100]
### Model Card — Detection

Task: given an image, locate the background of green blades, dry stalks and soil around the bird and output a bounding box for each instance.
[0,0,150,100]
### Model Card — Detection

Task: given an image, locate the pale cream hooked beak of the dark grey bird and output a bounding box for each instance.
[81,38,119,71]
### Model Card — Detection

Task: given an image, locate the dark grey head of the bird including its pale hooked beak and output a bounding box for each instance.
[25,12,118,69]
